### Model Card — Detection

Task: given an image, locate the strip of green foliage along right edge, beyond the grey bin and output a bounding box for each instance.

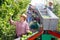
[53,0,60,32]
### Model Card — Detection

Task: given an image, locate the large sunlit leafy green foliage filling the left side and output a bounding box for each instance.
[0,0,30,40]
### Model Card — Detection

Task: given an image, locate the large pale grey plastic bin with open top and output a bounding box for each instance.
[38,8,59,30]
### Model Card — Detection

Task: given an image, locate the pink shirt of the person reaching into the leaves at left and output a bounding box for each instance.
[11,20,29,37]
